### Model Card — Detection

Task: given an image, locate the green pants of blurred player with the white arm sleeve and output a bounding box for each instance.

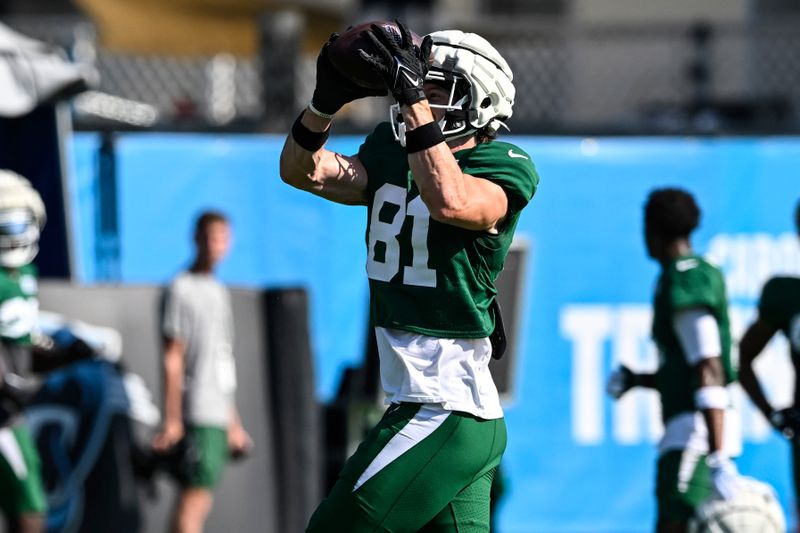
[656,450,712,522]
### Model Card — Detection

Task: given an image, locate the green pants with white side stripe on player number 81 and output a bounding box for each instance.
[306,403,506,533]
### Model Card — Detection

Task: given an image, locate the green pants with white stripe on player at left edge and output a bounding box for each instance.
[0,426,47,517]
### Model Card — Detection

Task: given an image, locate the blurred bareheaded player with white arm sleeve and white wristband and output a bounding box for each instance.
[608,189,741,533]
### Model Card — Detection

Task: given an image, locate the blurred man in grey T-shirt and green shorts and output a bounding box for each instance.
[153,211,252,533]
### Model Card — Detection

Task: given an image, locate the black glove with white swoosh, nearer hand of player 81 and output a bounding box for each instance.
[360,21,433,105]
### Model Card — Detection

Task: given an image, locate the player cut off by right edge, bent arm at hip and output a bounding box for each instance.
[739,203,800,520]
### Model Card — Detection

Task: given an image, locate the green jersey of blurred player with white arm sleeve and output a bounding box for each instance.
[653,255,735,422]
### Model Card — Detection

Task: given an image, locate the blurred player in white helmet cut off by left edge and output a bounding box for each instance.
[0,170,47,533]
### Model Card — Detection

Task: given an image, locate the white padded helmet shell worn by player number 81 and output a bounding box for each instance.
[428,30,516,135]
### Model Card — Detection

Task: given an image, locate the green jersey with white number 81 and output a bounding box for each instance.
[358,123,539,338]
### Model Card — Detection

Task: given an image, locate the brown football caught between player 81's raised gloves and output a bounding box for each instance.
[328,20,422,89]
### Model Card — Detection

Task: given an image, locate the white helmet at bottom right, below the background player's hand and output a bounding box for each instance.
[689,477,786,533]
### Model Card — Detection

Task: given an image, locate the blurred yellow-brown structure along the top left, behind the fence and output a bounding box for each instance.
[76,0,344,56]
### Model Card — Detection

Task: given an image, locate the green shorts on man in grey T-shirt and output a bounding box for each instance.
[182,425,229,489]
